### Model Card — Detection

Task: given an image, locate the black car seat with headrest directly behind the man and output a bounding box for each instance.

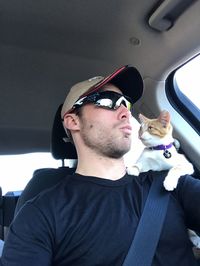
[15,104,77,215]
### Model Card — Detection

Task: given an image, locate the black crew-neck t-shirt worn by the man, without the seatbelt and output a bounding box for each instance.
[1,172,200,266]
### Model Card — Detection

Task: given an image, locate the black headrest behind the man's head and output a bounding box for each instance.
[51,104,77,160]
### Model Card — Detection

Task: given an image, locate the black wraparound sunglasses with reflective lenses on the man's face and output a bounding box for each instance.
[72,91,133,111]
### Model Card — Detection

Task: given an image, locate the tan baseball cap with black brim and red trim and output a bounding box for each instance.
[61,65,143,118]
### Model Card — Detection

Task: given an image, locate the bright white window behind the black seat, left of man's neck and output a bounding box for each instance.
[0,153,61,195]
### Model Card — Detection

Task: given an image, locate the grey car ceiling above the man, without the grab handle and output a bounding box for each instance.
[0,0,200,154]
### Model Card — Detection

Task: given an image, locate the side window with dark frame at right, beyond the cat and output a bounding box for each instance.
[166,55,200,133]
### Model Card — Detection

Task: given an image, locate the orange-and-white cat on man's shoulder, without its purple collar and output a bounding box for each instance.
[127,111,194,191]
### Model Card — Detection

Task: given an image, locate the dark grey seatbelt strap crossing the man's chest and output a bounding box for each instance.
[123,171,169,266]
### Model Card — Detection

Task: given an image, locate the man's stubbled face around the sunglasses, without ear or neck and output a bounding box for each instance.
[77,84,131,158]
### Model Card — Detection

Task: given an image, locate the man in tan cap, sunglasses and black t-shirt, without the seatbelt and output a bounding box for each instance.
[1,66,200,266]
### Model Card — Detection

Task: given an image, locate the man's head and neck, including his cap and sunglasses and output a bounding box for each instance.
[61,66,143,180]
